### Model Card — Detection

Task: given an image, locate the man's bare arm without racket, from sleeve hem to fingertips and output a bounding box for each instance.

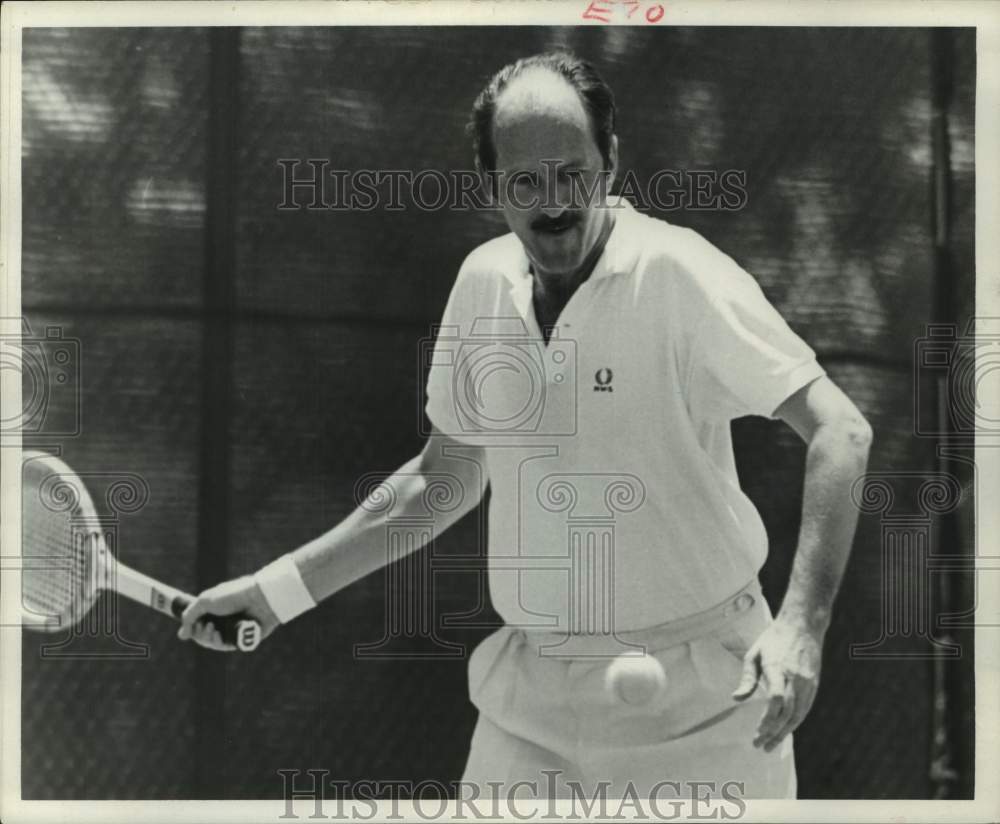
[733,377,872,750]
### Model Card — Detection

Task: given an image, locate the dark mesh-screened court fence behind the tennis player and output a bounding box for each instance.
[22,27,975,799]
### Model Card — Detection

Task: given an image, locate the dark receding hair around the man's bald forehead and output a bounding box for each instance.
[466,51,615,172]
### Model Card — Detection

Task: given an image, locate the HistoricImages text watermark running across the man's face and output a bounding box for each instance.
[277,158,748,212]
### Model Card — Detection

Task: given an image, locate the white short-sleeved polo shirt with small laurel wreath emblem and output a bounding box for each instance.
[427,201,824,632]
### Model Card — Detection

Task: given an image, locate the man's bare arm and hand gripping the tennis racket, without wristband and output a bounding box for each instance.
[178,431,486,650]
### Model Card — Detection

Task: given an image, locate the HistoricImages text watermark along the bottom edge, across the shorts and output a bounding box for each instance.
[278,768,746,821]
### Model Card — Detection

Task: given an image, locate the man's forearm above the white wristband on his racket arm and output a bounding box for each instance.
[291,456,482,601]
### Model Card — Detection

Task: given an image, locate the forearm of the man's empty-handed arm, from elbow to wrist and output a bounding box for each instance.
[779,421,871,633]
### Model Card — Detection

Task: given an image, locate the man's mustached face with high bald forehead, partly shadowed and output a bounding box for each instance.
[493,70,617,275]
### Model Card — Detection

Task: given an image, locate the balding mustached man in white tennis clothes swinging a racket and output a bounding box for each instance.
[180,53,871,798]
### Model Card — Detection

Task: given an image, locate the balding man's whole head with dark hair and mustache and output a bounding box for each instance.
[470,52,618,282]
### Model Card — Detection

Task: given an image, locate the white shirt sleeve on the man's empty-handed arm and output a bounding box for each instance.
[684,242,826,419]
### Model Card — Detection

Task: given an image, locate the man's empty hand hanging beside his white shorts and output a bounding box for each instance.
[733,615,823,752]
